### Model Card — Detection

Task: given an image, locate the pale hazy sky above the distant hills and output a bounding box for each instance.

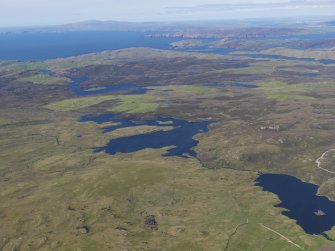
[0,0,335,27]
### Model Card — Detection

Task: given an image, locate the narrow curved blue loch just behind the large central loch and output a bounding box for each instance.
[69,77,150,96]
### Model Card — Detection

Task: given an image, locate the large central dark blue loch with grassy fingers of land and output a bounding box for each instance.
[80,114,213,157]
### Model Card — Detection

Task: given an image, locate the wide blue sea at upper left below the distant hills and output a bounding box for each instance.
[0,31,179,61]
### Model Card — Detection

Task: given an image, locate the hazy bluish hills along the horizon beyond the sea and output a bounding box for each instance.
[0,19,335,33]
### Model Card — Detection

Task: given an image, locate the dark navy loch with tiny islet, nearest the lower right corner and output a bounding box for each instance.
[256,174,335,236]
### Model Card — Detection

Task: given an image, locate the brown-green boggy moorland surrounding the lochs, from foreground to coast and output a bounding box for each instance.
[0,49,335,250]
